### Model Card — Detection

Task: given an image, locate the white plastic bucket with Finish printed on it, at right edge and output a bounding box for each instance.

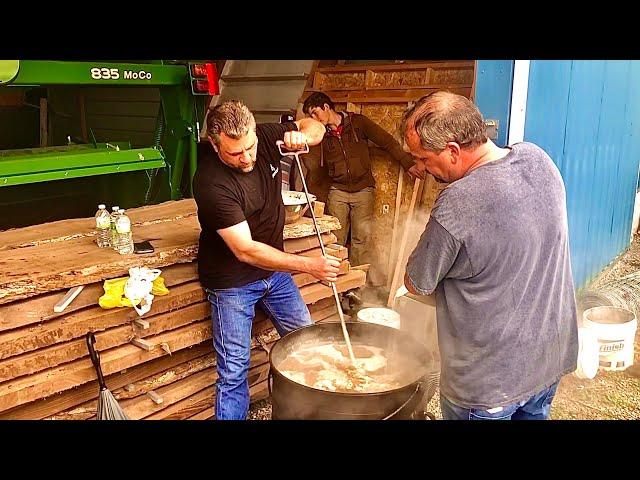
[582,306,638,371]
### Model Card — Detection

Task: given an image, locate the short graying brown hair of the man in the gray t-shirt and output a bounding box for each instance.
[400,91,487,152]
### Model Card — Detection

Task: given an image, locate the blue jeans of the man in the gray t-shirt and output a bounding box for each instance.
[440,381,560,420]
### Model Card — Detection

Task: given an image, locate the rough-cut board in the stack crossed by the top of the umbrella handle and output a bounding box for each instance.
[0,302,211,382]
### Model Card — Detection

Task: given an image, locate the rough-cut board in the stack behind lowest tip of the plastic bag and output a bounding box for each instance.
[0,282,205,359]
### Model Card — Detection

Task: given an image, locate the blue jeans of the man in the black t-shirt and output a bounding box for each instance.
[207,272,313,420]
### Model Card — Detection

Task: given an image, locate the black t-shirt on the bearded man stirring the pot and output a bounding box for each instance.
[193,123,297,289]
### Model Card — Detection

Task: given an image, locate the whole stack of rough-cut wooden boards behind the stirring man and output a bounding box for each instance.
[0,200,366,419]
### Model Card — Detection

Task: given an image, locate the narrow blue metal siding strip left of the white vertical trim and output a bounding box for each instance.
[475,60,513,146]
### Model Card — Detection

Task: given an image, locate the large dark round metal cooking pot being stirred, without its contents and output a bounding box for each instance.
[269,322,438,420]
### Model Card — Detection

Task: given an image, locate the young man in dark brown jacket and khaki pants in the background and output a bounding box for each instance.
[302,92,424,286]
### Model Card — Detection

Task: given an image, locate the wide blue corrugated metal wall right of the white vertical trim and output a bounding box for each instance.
[525,60,640,287]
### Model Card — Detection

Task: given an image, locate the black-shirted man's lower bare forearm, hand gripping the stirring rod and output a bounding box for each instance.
[217,220,340,282]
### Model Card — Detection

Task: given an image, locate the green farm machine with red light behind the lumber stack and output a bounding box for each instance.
[0,60,218,230]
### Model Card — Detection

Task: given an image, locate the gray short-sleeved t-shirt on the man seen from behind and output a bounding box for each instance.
[407,143,578,409]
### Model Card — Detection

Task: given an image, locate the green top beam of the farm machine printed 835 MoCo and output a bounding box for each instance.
[8,60,188,86]
